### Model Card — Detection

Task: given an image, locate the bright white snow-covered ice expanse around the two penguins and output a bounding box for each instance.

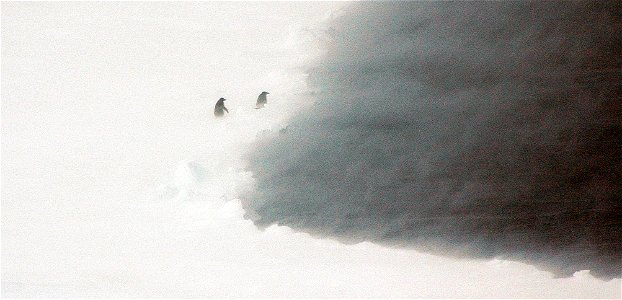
[1,2,620,298]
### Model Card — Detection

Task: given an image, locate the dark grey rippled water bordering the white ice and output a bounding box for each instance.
[244,1,622,279]
